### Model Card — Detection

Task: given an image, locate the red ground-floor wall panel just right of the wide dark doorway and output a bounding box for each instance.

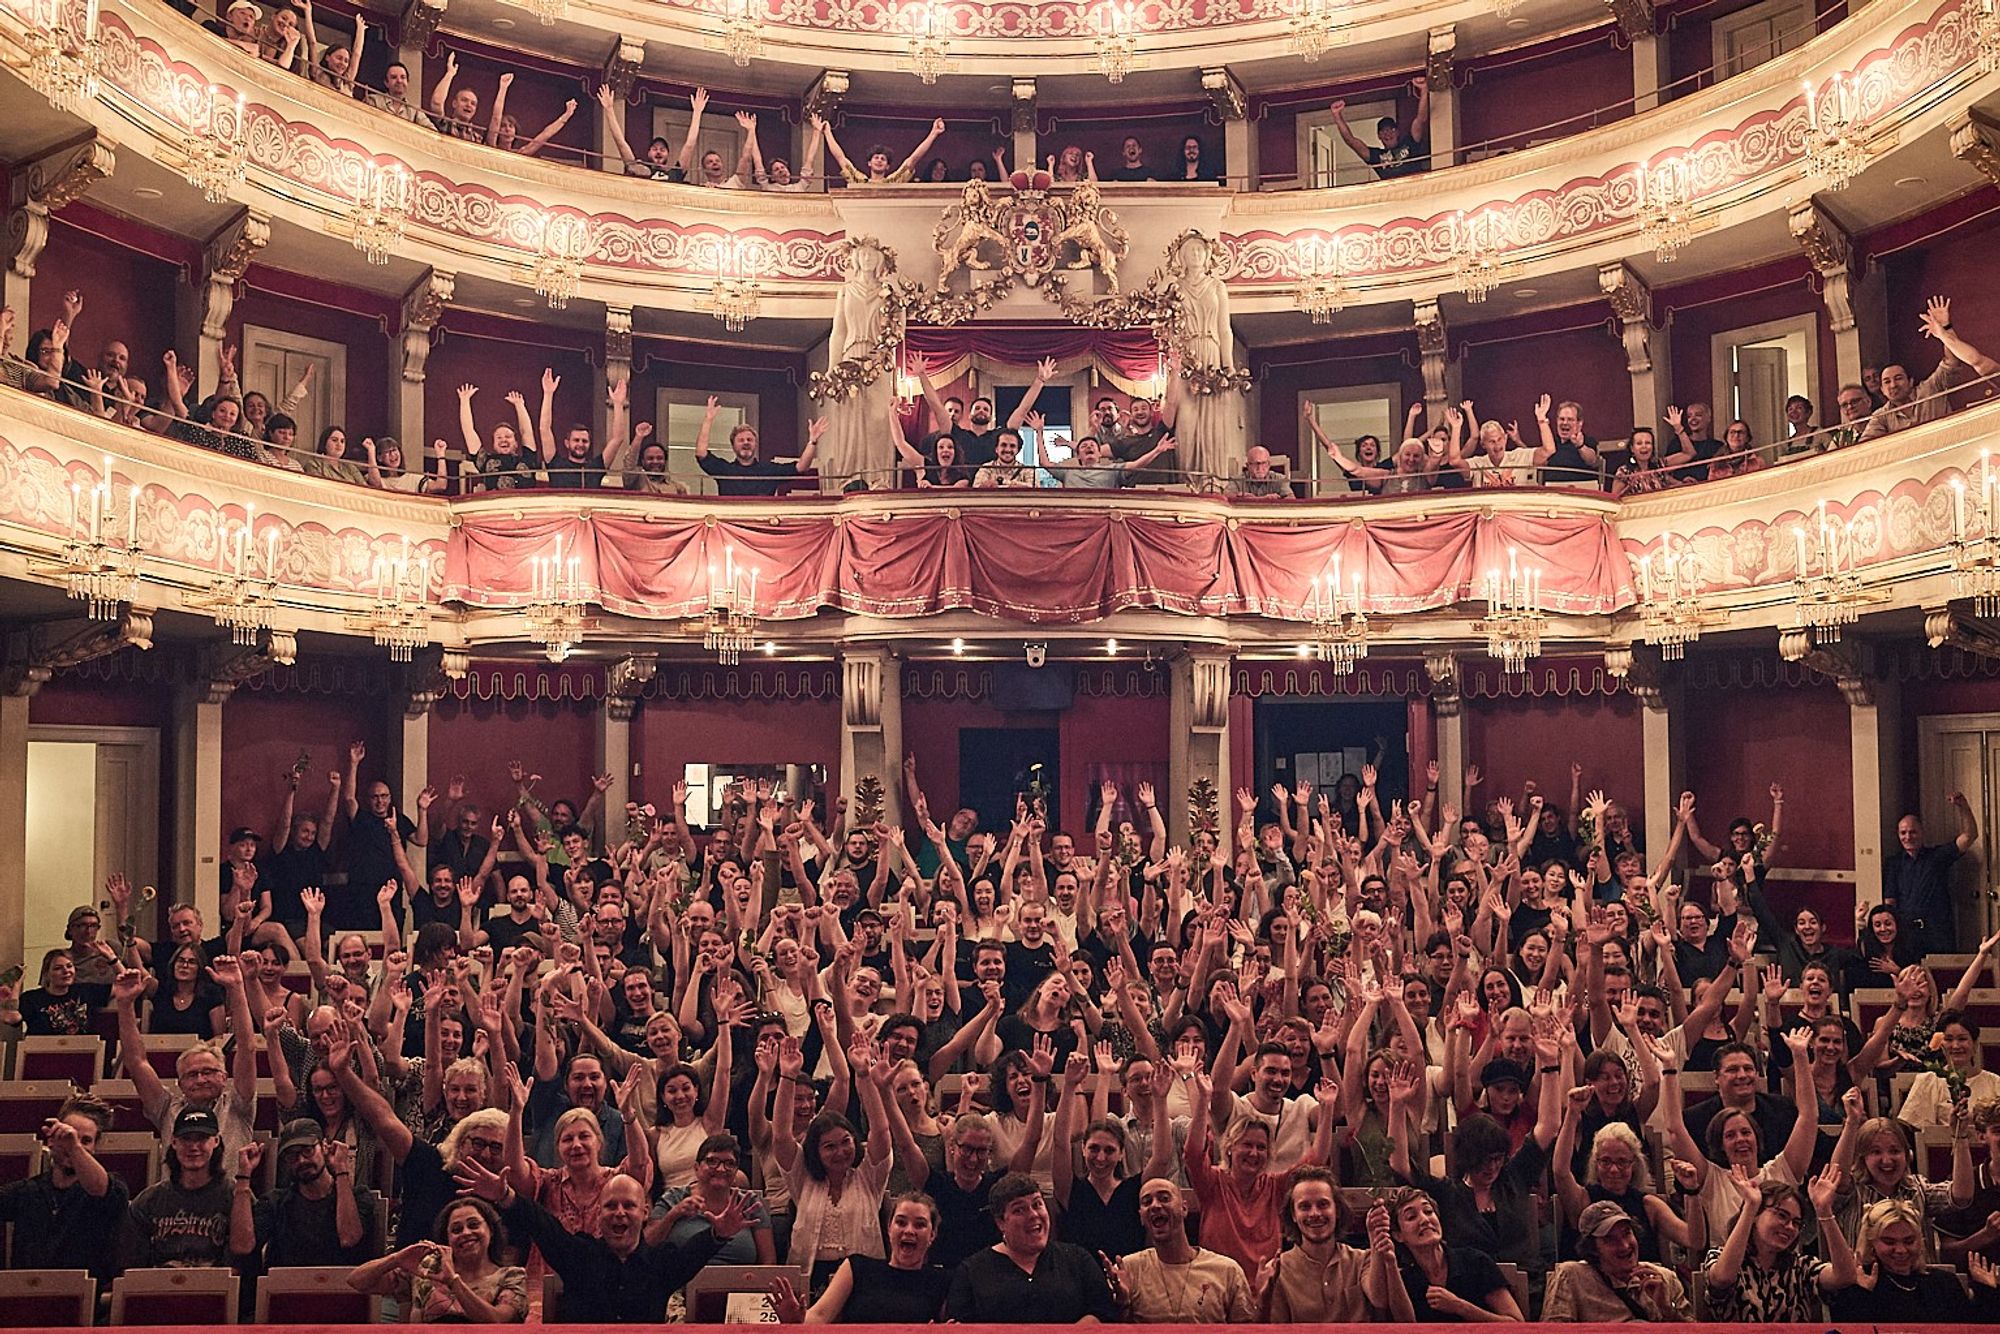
[1464,694,1650,846]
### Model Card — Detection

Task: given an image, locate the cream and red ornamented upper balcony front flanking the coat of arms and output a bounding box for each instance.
[0,0,2000,348]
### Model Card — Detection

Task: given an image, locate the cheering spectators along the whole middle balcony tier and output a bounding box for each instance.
[0,288,2000,500]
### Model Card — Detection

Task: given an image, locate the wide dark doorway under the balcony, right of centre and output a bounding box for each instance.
[1250,698,1422,834]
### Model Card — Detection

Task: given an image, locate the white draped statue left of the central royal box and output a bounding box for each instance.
[820,236,900,496]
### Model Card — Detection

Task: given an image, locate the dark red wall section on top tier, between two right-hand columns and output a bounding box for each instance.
[1458,28,1632,152]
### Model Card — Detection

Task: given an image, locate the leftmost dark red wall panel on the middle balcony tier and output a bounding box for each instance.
[32,214,194,390]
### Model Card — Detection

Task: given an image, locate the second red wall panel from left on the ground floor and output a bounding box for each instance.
[428,698,600,830]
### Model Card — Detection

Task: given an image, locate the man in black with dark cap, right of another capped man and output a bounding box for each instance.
[230,1116,376,1272]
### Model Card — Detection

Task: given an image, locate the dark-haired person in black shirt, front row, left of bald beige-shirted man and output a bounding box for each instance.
[944,1172,1118,1324]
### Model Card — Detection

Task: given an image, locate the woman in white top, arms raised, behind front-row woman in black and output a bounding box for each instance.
[770,1038,890,1290]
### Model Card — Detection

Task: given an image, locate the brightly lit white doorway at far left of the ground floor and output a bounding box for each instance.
[24,726,160,976]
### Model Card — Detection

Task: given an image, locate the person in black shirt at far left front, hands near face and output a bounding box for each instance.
[0,1094,130,1282]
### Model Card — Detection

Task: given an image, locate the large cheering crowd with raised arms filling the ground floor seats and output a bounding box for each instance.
[0,744,2000,1324]
